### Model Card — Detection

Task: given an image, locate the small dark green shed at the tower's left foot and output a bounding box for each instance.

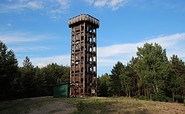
[53,83,70,98]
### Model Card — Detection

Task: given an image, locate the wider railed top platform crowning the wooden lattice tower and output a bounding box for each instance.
[68,14,99,28]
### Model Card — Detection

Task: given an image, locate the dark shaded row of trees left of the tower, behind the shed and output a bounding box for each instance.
[0,41,70,100]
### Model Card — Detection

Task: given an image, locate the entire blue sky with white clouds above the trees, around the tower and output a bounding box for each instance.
[0,0,185,75]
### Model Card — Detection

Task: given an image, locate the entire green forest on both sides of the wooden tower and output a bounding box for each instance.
[0,41,185,103]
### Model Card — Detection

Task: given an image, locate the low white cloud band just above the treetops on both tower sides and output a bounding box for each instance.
[13,33,185,74]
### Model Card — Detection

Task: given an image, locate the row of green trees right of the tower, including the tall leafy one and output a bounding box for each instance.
[98,43,185,102]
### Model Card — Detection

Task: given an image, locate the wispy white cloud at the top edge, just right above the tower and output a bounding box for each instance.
[85,0,128,11]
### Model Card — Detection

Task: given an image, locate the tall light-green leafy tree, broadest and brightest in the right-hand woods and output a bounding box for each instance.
[135,43,169,99]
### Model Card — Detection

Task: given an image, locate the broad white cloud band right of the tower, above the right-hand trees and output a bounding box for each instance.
[98,33,185,73]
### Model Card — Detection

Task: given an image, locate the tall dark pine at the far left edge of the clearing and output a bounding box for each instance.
[0,41,18,99]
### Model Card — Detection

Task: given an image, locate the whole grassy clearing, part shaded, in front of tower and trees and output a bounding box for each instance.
[0,97,185,114]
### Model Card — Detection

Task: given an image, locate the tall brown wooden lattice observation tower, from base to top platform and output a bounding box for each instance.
[68,14,99,97]
